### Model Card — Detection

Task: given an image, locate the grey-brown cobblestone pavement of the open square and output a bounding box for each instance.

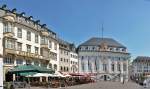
[16,82,146,89]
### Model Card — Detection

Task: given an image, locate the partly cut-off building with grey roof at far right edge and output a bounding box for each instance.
[132,56,150,79]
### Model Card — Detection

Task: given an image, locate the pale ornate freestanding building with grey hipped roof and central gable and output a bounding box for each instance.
[78,37,130,81]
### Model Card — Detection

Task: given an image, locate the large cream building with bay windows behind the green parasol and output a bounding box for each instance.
[0,5,59,81]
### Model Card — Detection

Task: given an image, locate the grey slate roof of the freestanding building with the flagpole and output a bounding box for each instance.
[79,37,126,48]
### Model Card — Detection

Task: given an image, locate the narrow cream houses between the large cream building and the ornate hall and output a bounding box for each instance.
[59,39,78,73]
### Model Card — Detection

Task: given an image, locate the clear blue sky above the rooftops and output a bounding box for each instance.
[0,0,150,58]
